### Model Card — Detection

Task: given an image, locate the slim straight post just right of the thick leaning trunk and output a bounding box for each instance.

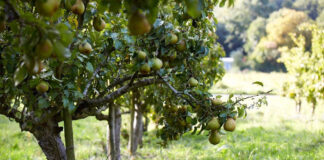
[63,108,75,160]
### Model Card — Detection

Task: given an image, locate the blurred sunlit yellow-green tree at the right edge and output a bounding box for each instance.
[280,24,324,115]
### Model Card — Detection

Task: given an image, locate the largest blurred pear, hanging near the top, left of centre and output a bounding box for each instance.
[128,11,151,36]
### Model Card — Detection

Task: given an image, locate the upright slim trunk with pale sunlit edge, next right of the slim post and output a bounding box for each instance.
[107,105,121,160]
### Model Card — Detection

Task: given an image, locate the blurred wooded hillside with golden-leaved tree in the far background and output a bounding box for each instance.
[215,0,324,72]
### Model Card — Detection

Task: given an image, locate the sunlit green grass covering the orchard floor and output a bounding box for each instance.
[0,73,324,160]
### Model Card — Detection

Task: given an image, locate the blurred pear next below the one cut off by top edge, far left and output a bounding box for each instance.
[36,39,53,59]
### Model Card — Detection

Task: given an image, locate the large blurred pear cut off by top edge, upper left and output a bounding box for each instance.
[36,0,61,17]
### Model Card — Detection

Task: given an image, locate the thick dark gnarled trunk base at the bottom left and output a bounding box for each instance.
[30,121,67,160]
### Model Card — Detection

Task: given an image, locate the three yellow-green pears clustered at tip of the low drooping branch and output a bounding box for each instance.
[206,117,236,145]
